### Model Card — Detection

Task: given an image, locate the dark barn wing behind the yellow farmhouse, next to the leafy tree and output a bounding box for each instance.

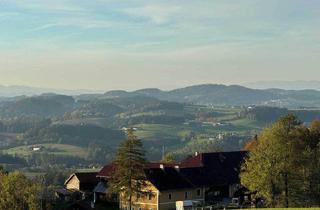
[180,151,248,203]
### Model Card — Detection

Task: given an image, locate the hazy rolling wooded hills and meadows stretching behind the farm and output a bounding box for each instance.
[0,85,320,174]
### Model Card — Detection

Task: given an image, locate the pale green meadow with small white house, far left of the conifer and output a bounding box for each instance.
[4,144,87,157]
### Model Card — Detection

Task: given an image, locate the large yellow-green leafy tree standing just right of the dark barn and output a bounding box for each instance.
[241,114,306,207]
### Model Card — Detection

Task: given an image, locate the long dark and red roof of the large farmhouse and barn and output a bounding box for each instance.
[145,151,247,191]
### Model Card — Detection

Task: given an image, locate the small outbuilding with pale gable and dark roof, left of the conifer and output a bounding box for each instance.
[64,172,98,200]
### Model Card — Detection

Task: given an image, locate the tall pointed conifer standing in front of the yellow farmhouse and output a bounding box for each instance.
[109,129,146,210]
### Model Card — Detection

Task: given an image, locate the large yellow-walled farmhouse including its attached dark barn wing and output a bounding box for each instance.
[120,151,247,210]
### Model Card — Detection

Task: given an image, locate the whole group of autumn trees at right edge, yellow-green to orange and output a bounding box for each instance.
[241,114,320,207]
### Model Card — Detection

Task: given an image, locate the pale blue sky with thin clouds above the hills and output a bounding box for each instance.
[0,0,320,90]
